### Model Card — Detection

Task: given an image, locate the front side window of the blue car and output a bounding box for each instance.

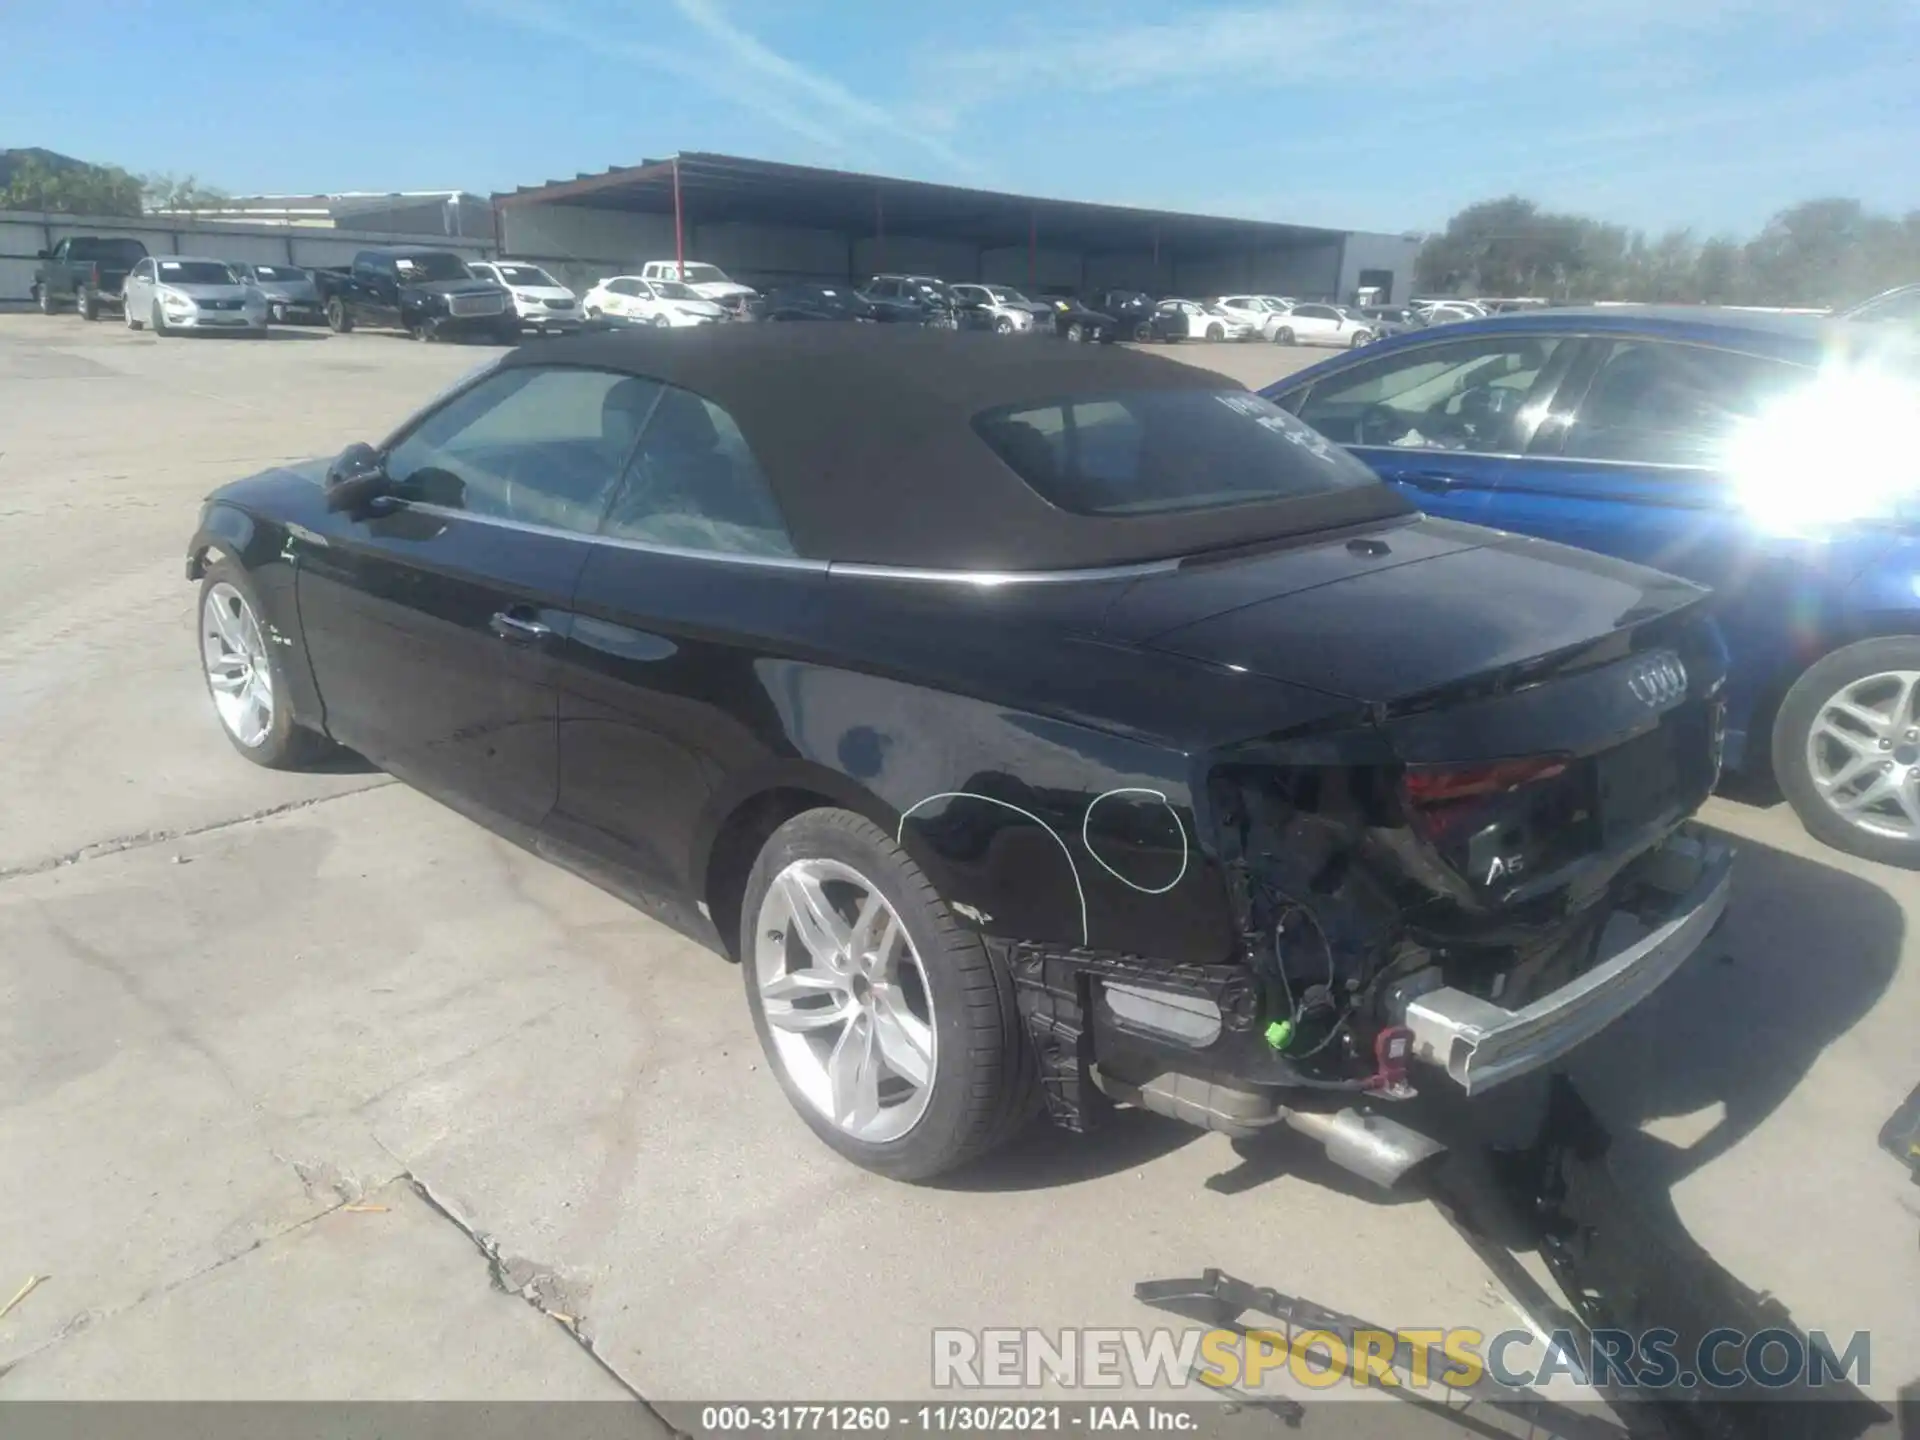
[1294,337,1561,453]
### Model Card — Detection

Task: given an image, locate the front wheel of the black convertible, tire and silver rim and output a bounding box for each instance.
[200,557,332,770]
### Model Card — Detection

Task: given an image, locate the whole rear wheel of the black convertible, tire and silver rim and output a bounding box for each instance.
[739,810,1037,1181]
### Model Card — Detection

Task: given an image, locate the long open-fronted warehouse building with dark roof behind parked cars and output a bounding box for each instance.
[493,154,1419,301]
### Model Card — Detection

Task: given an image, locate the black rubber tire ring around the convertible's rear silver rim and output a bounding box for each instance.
[739,810,1025,1181]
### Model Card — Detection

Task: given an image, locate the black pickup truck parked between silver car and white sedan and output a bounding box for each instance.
[313,246,520,346]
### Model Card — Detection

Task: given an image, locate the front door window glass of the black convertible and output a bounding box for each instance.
[386,367,660,536]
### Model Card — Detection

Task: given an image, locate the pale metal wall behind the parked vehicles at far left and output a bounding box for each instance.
[0,209,493,303]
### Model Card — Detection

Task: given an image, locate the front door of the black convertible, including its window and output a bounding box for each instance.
[296,365,659,826]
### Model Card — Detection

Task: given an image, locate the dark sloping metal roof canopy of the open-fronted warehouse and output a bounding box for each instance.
[493,152,1346,259]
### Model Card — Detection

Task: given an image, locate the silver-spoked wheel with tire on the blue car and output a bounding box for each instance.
[1772,636,1920,870]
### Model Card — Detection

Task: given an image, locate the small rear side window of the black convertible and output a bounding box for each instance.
[601,388,793,555]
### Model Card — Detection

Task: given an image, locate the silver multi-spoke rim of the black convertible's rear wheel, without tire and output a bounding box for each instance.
[753,858,937,1144]
